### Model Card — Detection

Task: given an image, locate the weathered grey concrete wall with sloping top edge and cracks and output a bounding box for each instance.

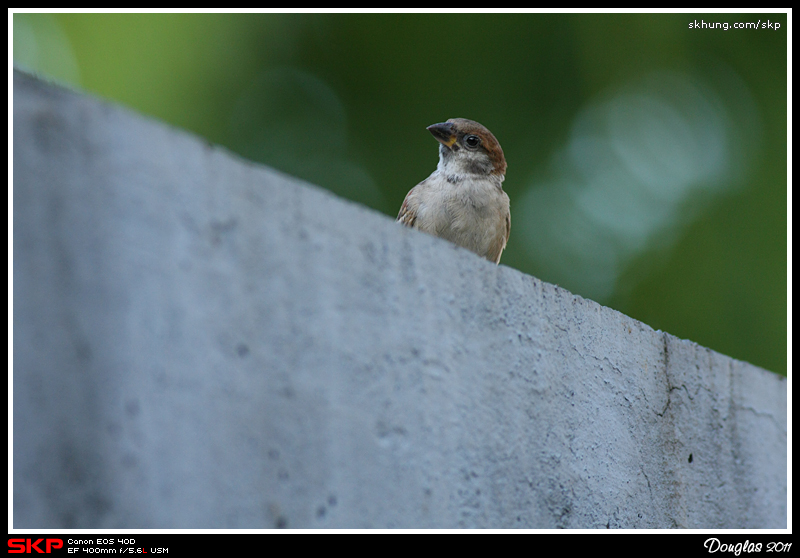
[13,73,787,529]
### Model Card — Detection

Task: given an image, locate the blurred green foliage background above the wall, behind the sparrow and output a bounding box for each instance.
[13,13,787,374]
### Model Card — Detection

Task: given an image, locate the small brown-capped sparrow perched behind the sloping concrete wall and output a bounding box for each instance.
[397,118,511,264]
